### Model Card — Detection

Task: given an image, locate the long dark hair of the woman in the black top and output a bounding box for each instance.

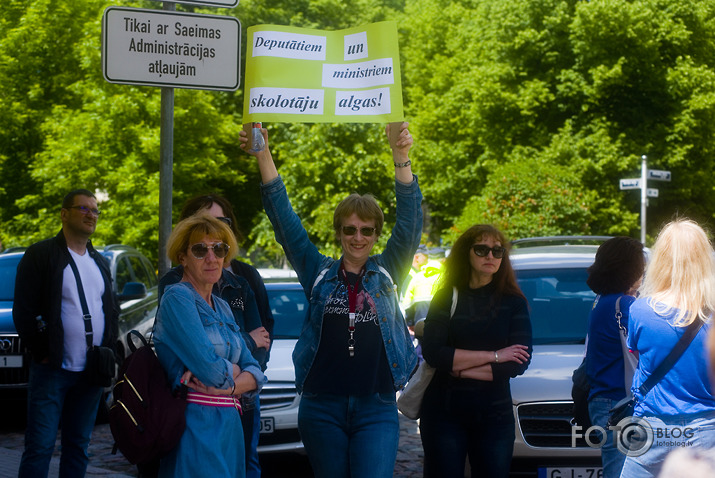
[440,224,526,299]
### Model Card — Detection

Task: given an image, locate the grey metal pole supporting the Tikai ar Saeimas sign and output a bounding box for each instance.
[159,2,176,277]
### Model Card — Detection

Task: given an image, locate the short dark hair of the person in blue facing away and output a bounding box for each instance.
[586,236,645,295]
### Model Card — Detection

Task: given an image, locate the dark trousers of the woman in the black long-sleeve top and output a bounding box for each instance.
[420,393,515,478]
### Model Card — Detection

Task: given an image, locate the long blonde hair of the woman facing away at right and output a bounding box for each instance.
[640,219,715,327]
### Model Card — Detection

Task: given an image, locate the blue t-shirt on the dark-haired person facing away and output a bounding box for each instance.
[586,294,635,400]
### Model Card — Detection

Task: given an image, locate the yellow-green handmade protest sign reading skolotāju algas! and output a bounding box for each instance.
[243,22,404,123]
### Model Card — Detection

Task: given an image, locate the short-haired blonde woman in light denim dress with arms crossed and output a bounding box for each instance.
[154,215,265,478]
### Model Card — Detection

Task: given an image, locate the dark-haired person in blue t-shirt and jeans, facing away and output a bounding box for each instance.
[586,236,645,478]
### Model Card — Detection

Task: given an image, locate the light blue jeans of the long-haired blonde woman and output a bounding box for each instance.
[621,414,715,478]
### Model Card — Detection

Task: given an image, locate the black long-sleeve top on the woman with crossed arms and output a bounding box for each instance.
[422,283,532,404]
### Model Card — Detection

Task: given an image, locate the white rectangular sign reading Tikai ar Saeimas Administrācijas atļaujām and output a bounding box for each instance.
[102,7,241,91]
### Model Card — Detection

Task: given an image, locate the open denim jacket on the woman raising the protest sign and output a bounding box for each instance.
[261,176,422,393]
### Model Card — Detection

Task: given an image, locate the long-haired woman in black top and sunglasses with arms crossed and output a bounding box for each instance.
[420,225,531,478]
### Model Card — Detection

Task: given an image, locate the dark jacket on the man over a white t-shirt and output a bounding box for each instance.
[12,231,119,368]
